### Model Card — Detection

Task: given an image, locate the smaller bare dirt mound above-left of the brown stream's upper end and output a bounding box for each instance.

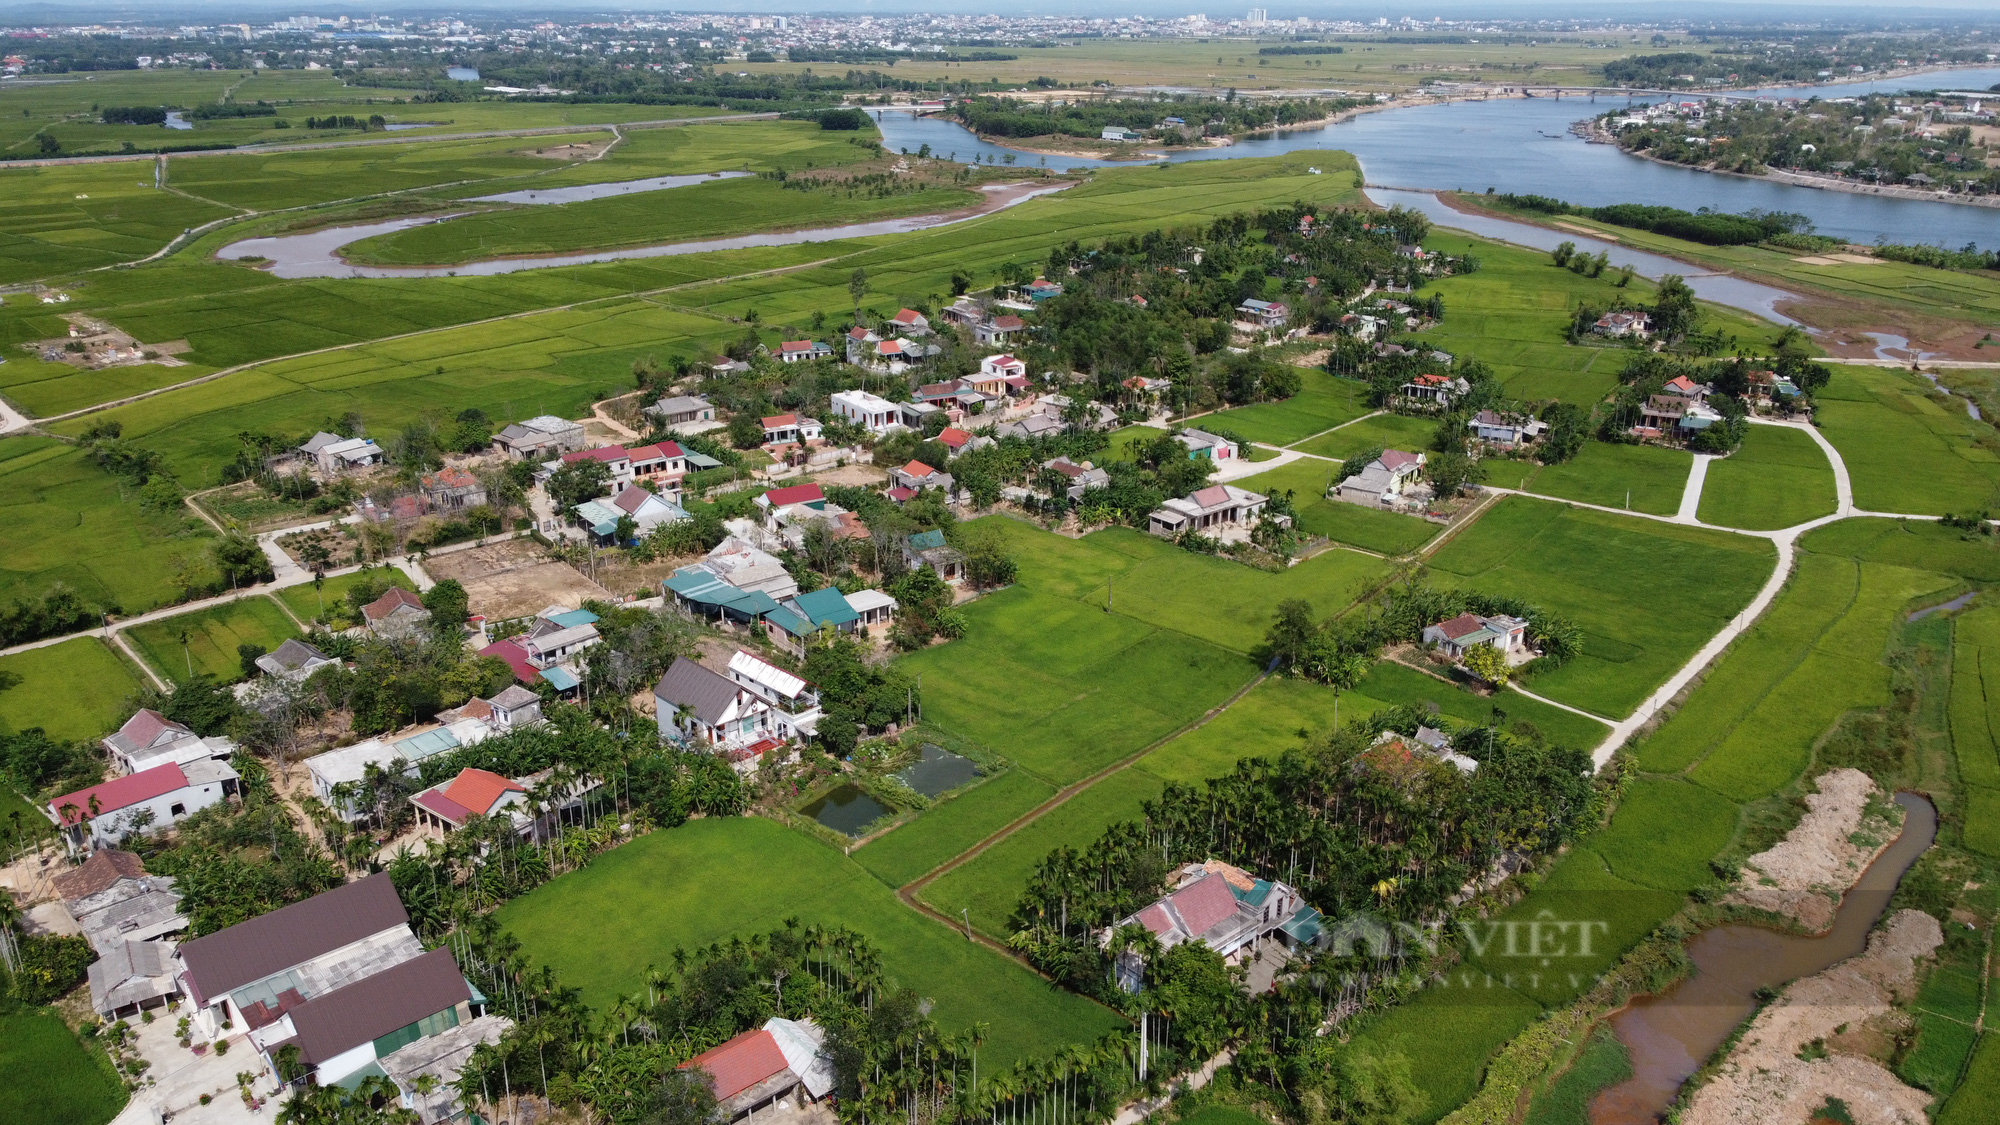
[1722,769,1900,933]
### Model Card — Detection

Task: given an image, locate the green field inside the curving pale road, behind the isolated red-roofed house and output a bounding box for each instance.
[1430,496,1774,717]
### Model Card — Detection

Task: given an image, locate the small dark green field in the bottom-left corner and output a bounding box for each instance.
[0,1001,126,1125]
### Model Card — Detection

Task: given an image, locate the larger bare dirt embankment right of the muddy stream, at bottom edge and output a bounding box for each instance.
[1680,911,1944,1125]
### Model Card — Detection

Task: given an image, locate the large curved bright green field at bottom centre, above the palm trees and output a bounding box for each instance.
[486,817,1122,1071]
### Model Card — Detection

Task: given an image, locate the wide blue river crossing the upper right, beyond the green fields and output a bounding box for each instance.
[874,66,2000,248]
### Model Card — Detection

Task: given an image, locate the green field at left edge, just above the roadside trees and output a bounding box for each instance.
[0,436,212,613]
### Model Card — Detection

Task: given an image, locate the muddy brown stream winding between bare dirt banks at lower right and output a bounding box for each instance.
[1590,793,1938,1125]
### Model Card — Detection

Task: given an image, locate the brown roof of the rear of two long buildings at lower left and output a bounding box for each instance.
[176,873,410,1007]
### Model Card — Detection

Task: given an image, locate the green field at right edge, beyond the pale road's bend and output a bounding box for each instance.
[1818,366,2000,516]
